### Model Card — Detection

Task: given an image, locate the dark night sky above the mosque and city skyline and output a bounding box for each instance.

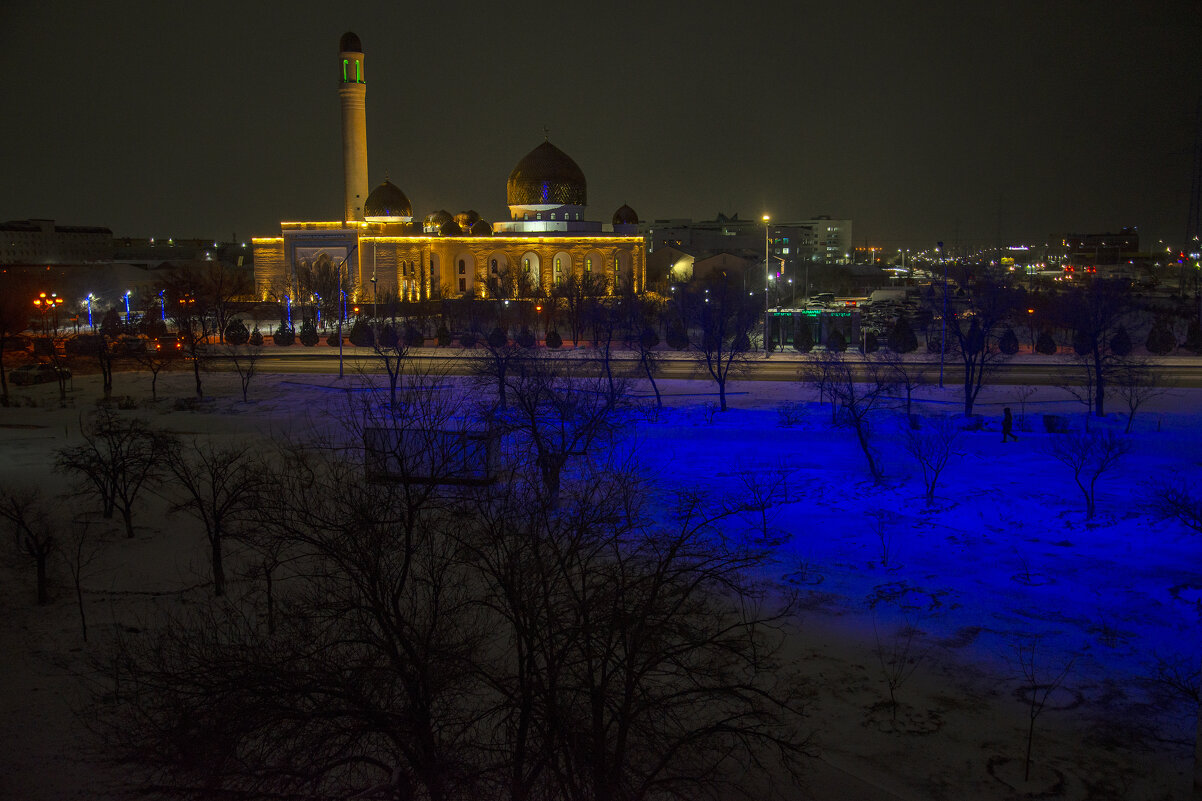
[0,0,1202,248]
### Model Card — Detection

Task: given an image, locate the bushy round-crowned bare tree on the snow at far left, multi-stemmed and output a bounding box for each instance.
[55,408,162,538]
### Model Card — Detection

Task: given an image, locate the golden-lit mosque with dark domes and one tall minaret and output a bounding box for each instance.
[254,32,647,303]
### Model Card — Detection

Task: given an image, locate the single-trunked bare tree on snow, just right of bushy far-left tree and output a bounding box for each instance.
[163,440,264,595]
